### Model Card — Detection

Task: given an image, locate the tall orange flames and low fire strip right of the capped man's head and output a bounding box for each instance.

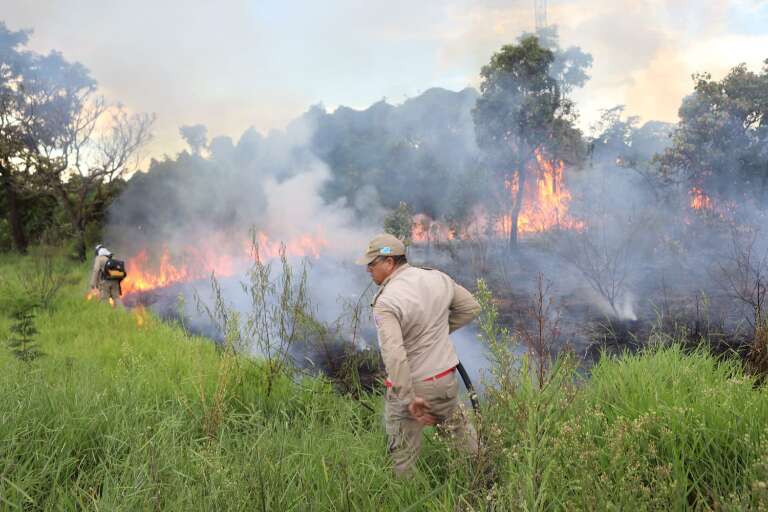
[411,151,584,242]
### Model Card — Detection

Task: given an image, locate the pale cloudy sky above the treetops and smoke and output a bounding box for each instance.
[0,0,768,157]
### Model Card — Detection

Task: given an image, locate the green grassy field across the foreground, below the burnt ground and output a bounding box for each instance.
[0,250,768,511]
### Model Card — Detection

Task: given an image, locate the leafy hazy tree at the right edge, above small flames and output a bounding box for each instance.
[656,59,768,208]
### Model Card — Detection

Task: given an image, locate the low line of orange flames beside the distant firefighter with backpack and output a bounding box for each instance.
[122,233,328,295]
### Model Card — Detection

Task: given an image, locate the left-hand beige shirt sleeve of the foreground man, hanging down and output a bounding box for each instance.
[373,304,415,403]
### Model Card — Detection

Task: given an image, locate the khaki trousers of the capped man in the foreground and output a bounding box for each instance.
[384,371,479,476]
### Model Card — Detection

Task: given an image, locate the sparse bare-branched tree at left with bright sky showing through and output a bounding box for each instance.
[24,67,155,260]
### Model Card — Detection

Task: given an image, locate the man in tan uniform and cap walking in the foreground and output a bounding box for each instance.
[356,235,480,476]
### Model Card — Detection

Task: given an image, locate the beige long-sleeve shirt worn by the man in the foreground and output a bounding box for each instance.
[371,264,480,402]
